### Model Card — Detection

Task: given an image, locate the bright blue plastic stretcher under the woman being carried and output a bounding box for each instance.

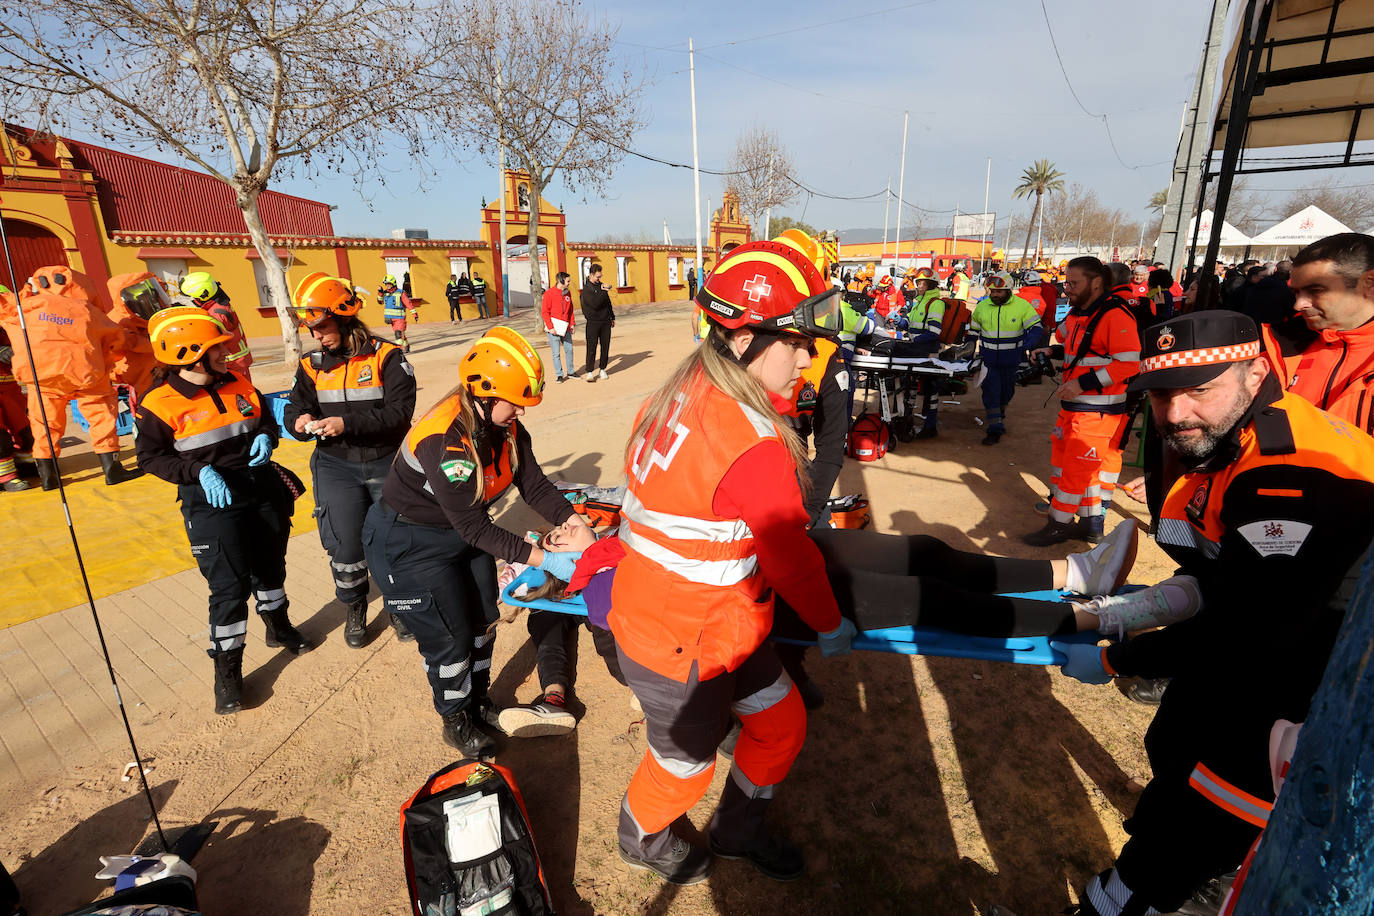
[502,569,1101,665]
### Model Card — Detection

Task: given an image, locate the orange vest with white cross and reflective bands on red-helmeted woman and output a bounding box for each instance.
[609,383,780,683]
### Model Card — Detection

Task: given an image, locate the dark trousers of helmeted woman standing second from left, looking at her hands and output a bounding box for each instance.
[311,448,396,604]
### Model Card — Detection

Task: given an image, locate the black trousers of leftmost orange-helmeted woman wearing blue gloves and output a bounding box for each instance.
[177,464,293,655]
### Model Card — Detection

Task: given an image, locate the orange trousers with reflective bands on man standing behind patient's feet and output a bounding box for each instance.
[1050,411,1131,522]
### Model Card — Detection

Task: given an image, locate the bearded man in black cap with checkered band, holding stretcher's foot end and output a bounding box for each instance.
[1063,310,1374,916]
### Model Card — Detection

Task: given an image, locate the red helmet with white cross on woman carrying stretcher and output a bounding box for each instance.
[697,242,842,336]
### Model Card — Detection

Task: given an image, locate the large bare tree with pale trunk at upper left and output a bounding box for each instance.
[0,0,464,362]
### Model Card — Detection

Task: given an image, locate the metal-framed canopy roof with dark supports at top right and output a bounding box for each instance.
[1198,0,1374,293]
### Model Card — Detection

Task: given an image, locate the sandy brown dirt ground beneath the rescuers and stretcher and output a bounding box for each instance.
[0,304,1169,916]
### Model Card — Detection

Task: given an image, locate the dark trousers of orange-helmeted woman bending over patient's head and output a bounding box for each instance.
[363,503,500,715]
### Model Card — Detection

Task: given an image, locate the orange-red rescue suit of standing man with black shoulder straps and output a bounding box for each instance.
[1050,297,1140,526]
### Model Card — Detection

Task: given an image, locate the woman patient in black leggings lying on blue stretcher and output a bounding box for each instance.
[525,520,1201,639]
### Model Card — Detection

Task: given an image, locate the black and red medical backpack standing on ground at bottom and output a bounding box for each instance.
[401,759,554,916]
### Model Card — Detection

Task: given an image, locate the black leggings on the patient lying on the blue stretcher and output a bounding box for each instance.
[774,527,1077,639]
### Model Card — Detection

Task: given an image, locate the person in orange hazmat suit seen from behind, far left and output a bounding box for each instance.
[0,266,143,490]
